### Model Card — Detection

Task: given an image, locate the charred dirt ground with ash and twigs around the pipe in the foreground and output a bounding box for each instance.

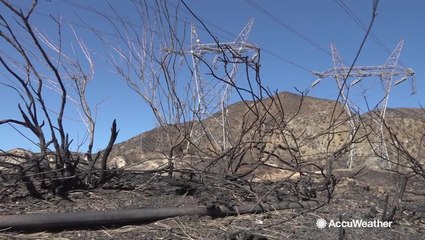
[0,170,425,240]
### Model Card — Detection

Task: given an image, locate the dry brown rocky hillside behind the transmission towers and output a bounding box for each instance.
[108,92,425,171]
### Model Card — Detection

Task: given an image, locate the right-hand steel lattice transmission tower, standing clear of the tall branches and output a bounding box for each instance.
[311,40,416,168]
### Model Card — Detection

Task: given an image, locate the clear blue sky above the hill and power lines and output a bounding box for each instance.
[0,0,425,150]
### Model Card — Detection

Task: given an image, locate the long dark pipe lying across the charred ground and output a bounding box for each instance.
[0,201,319,231]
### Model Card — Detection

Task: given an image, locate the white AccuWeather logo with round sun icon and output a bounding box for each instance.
[316,218,393,229]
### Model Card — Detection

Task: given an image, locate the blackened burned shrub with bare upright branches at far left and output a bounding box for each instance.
[0,1,118,197]
